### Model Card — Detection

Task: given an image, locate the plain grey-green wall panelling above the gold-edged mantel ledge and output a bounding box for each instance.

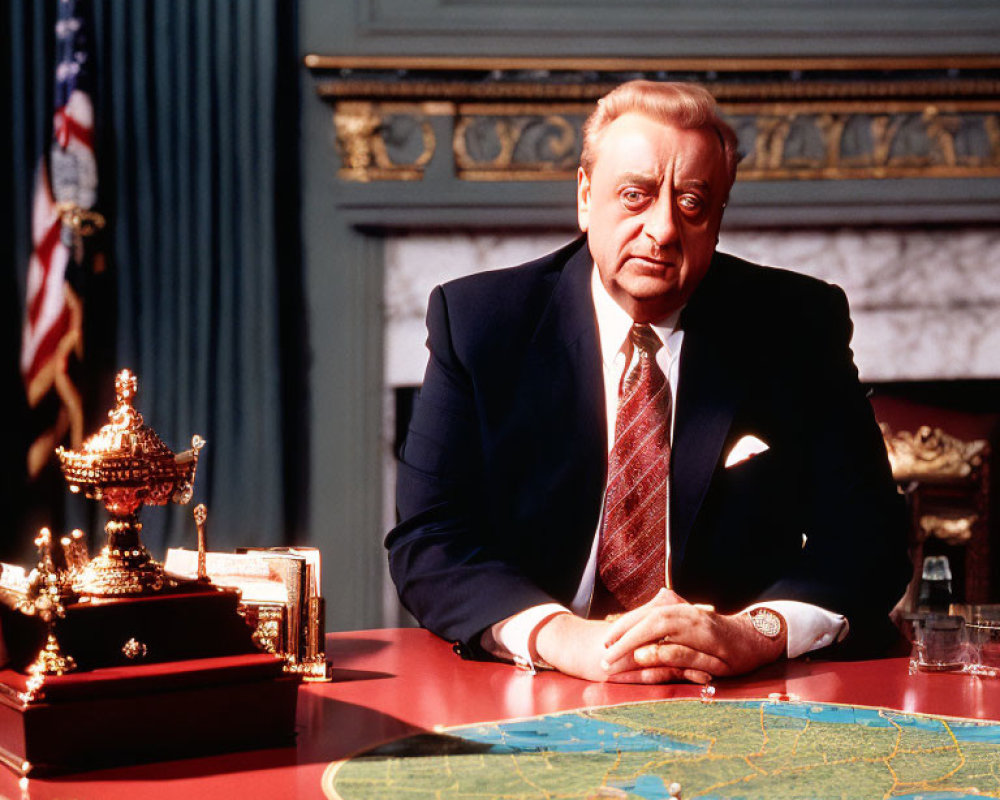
[323,0,998,57]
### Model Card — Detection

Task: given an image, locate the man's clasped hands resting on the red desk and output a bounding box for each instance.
[534,589,786,684]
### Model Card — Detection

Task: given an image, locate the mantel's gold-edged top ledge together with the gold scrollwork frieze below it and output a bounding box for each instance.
[306,56,1000,181]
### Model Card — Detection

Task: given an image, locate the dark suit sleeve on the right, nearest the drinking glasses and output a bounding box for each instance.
[761,287,911,651]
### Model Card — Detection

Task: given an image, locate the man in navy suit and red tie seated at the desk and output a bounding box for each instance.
[386,82,910,682]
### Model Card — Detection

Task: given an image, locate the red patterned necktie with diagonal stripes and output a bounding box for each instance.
[597,324,670,609]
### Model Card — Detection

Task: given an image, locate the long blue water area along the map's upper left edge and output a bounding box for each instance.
[461,716,708,756]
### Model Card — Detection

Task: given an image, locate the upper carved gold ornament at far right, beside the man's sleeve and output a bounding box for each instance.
[881,423,987,481]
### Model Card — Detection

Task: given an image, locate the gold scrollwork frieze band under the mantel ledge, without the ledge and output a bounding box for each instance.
[335,103,1000,181]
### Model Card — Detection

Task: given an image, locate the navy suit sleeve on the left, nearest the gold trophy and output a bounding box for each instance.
[386,287,564,655]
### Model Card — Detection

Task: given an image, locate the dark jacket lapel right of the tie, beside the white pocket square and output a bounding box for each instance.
[670,259,744,569]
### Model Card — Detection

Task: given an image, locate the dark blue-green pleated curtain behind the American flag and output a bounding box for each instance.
[2,0,300,557]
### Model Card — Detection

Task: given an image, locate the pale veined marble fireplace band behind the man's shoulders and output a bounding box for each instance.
[385,227,1000,386]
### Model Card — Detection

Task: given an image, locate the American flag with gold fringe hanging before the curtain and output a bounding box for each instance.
[21,0,104,478]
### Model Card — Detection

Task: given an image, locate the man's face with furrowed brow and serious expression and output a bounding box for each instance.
[577,113,729,322]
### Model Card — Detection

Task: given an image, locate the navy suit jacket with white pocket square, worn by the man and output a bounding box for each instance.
[386,238,911,653]
